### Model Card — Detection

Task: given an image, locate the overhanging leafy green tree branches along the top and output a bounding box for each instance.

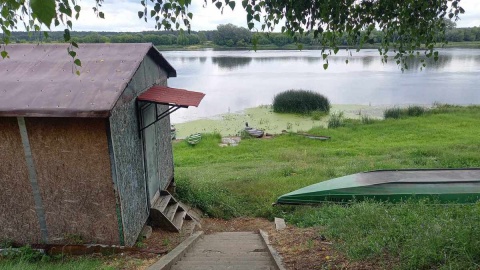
[0,0,465,70]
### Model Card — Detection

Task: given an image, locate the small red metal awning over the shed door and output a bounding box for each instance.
[137,85,205,107]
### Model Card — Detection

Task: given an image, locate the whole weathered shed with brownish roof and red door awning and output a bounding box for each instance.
[0,44,204,246]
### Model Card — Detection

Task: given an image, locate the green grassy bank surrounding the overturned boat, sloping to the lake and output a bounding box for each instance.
[174,105,480,269]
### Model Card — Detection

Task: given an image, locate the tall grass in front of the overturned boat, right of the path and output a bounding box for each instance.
[287,201,480,269]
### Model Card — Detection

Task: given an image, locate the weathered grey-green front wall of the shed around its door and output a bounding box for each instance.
[110,53,173,246]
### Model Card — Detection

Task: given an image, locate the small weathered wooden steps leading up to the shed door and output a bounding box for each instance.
[150,190,193,232]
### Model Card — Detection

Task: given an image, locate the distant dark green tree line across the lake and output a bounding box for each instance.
[12,22,480,48]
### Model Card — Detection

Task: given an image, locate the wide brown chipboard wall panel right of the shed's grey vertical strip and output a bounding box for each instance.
[25,118,120,244]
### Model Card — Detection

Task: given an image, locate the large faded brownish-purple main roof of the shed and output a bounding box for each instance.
[0,43,176,117]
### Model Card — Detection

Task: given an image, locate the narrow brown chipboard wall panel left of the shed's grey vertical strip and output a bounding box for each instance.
[0,117,41,244]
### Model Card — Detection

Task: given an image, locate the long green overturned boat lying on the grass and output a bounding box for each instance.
[277,168,480,204]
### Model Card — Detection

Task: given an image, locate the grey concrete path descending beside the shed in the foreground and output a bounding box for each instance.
[171,232,277,270]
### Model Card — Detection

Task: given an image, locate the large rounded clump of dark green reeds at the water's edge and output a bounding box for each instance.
[273,90,330,114]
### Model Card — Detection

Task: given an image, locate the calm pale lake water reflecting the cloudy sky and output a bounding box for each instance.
[162,49,480,123]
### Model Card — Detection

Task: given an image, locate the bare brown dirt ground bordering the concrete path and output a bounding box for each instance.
[108,218,388,270]
